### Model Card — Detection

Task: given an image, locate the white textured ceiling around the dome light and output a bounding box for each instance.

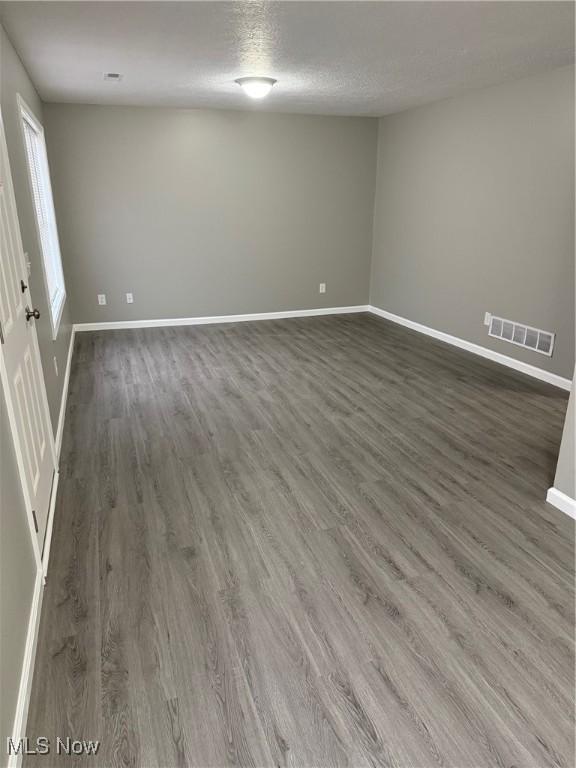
[0,2,574,115]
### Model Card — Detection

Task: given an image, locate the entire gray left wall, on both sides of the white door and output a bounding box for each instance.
[0,27,71,765]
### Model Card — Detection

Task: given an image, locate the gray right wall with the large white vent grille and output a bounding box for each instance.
[371,68,574,378]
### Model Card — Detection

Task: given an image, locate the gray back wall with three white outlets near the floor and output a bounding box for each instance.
[44,104,377,322]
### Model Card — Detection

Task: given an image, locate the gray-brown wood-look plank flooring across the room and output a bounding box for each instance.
[27,315,574,768]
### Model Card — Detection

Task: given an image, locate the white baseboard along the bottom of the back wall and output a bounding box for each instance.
[74,304,368,332]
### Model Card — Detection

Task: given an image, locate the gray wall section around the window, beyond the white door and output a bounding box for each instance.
[0,27,71,433]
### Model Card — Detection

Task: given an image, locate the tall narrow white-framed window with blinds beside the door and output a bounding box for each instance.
[18,97,66,339]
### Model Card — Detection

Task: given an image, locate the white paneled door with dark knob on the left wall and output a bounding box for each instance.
[0,111,56,559]
